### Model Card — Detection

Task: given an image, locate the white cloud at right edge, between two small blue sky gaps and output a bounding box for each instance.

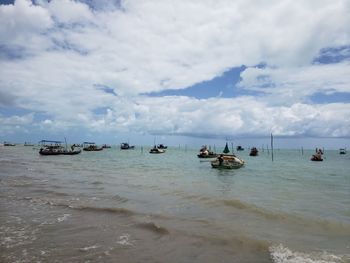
[239,62,350,105]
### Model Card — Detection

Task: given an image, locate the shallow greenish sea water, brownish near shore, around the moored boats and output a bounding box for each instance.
[0,146,350,263]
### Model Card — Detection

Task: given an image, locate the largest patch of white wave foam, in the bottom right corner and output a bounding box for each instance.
[269,244,346,263]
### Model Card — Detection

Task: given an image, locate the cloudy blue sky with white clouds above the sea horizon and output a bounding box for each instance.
[0,0,350,148]
